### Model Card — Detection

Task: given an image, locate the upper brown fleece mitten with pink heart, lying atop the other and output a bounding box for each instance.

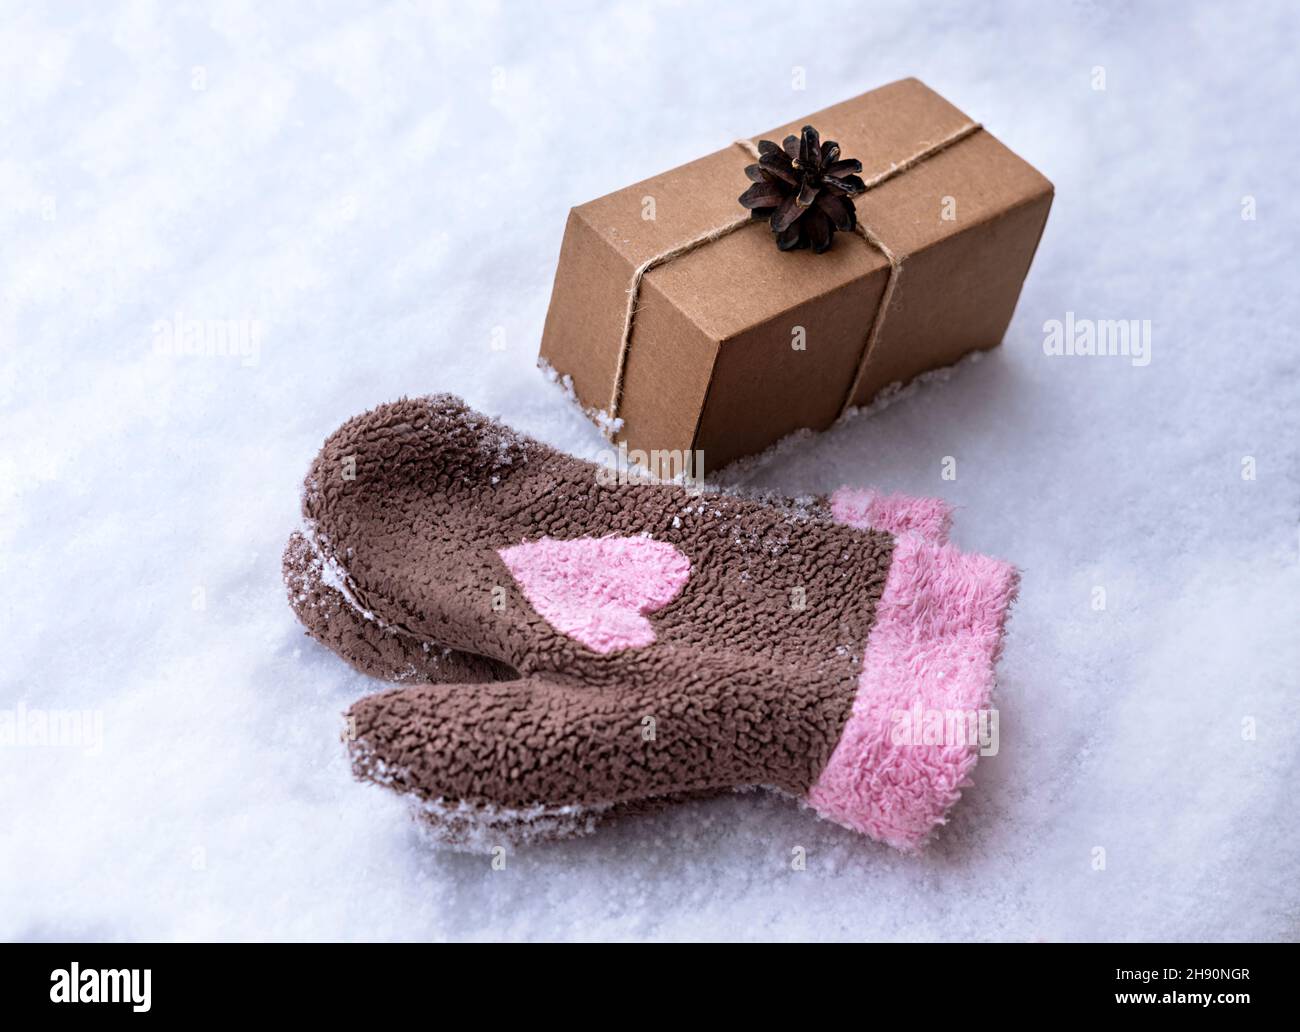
[292,396,1015,849]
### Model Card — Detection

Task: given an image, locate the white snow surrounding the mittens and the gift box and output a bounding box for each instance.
[0,0,1300,940]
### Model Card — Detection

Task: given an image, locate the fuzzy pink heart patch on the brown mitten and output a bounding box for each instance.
[497,537,690,654]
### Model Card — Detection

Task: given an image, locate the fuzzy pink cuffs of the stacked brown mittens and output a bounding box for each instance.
[807,491,1018,850]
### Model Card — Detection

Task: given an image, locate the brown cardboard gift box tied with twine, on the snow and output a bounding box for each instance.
[540,79,1053,472]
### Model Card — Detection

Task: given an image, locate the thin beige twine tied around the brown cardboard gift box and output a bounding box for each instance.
[606,122,983,441]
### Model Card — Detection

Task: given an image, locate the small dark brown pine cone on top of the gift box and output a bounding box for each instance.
[740,125,867,255]
